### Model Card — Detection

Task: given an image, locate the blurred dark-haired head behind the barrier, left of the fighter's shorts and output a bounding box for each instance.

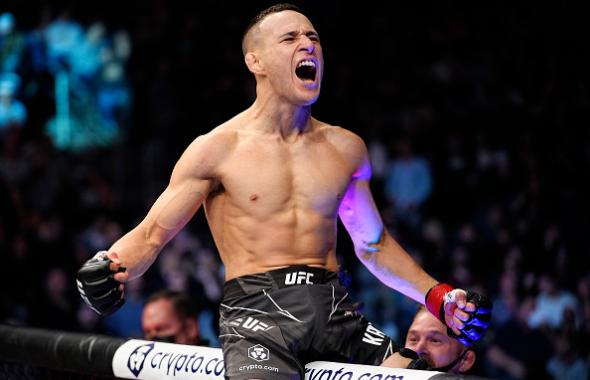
[141,290,208,346]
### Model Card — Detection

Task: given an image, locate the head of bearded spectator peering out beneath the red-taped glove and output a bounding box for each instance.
[405,306,476,374]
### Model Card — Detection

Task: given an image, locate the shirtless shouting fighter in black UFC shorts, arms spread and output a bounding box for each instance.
[78,4,490,379]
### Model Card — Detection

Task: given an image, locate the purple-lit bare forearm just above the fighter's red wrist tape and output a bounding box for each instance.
[355,231,437,304]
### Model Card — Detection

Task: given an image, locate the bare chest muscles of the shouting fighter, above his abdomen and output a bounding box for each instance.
[219,137,354,216]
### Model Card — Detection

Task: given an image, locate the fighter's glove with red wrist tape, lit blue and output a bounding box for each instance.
[425,284,492,346]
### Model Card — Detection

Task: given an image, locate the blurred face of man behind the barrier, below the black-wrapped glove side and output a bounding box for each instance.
[141,299,186,343]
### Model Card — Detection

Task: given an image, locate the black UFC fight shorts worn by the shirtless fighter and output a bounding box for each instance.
[219,266,397,380]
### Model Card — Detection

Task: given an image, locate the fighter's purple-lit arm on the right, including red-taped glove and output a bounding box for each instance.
[339,146,492,344]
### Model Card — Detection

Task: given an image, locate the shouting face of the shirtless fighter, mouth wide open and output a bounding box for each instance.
[254,11,324,105]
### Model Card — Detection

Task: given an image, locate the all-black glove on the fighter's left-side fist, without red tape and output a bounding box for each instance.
[76,251,125,315]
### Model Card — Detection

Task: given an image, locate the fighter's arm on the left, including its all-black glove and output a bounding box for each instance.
[77,135,228,314]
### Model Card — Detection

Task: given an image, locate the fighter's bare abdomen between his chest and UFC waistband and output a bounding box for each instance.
[206,195,338,280]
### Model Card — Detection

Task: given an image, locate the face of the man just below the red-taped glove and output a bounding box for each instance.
[405,311,465,372]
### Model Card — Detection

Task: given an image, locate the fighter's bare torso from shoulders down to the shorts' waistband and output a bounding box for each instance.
[205,114,360,279]
